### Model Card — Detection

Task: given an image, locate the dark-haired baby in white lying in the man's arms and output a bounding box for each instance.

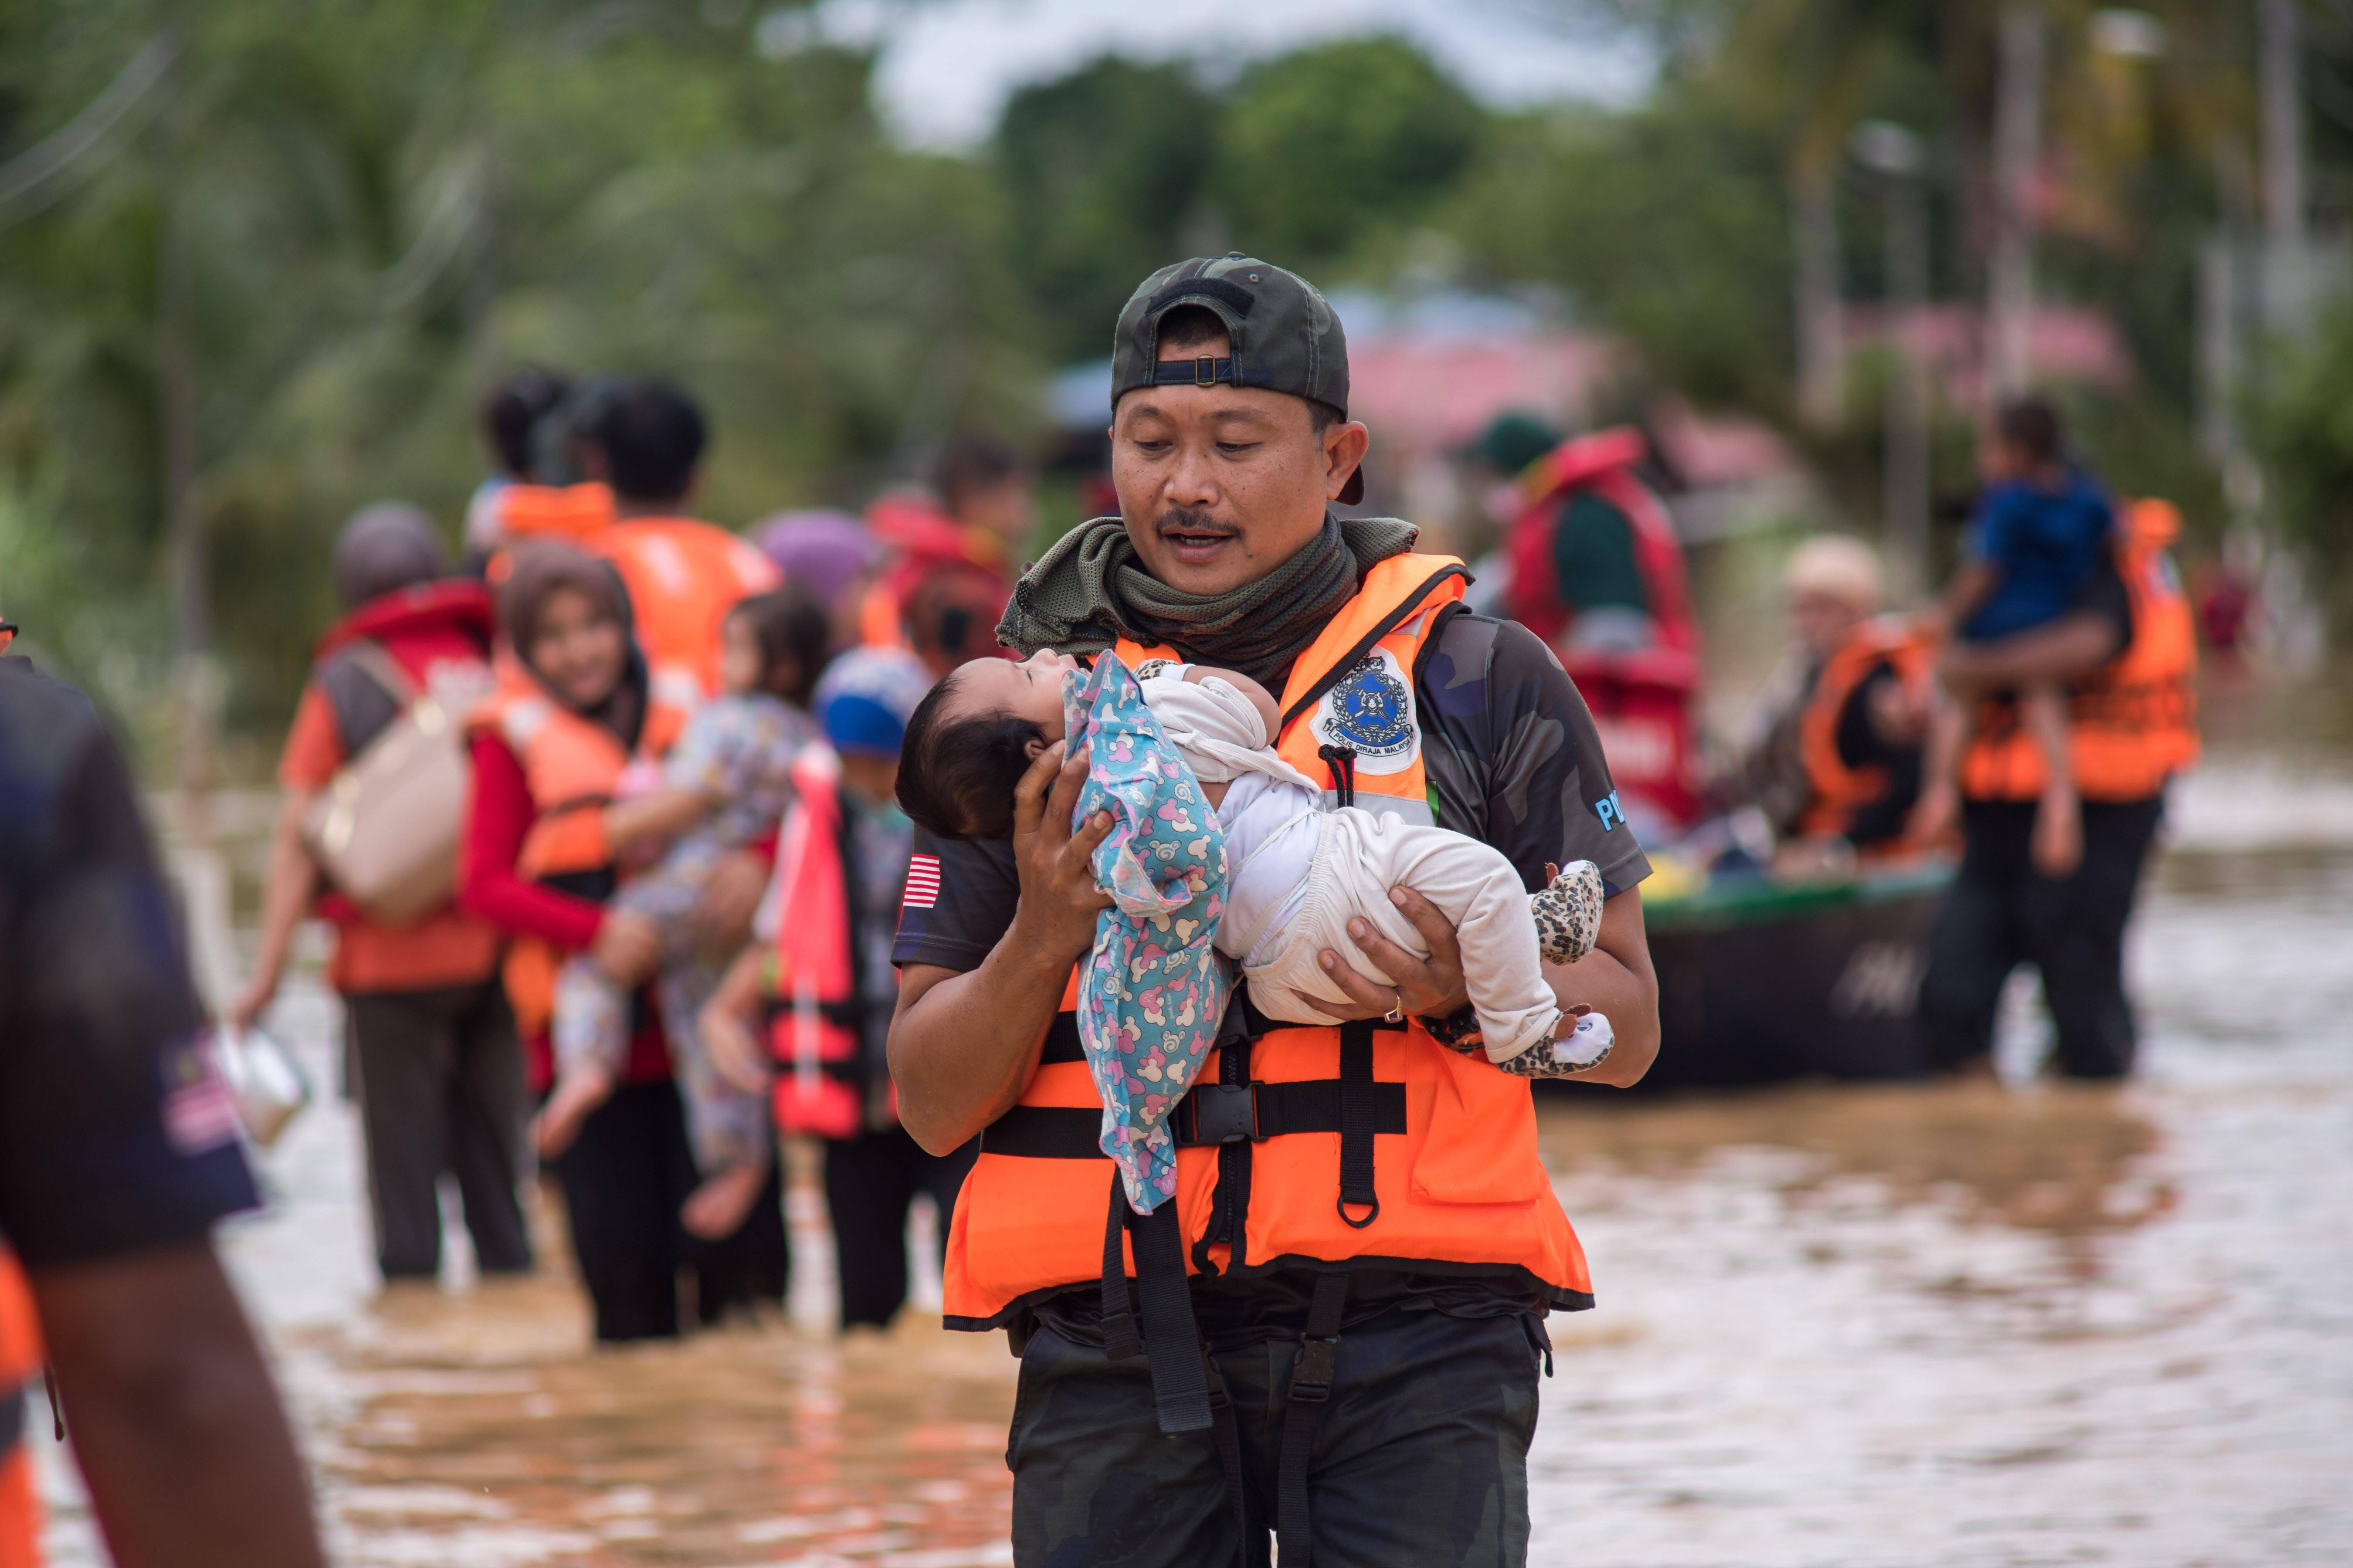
[899,652,1610,1078]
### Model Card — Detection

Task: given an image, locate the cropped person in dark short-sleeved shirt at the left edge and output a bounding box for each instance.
[0,626,322,1568]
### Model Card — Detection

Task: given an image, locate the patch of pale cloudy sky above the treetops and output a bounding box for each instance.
[763,0,1652,148]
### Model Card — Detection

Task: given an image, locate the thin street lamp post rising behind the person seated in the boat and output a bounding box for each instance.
[1854,120,1929,596]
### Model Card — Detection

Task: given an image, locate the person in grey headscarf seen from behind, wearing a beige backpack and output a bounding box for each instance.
[228,501,532,1281]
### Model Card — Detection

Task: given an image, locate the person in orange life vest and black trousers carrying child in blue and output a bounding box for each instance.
[1918,499,2198,1078]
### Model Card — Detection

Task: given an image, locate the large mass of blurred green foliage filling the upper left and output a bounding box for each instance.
[0,0,1037,753]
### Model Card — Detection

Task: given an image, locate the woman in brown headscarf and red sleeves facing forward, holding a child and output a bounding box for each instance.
[459,544,786,1342]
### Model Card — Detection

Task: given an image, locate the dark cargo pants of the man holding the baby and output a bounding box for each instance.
[1005,1311,1541,1568]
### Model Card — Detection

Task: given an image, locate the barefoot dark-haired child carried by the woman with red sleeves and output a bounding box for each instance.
[536,589,831,1238]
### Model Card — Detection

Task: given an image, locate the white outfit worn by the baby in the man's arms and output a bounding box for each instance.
[1139,664,1563,1062]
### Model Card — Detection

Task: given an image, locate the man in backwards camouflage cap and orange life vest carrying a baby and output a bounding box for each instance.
[889,254,1659,1566]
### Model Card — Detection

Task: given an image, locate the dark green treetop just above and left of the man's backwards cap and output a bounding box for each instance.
[993,57,1221,360]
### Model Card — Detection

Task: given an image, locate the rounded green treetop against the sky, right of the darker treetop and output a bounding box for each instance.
[1212,37,1487,273]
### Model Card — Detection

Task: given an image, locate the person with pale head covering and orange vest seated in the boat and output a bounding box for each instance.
[1725,535,1932,855]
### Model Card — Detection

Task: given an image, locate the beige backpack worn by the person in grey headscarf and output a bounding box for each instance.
[304,643,487,925]
